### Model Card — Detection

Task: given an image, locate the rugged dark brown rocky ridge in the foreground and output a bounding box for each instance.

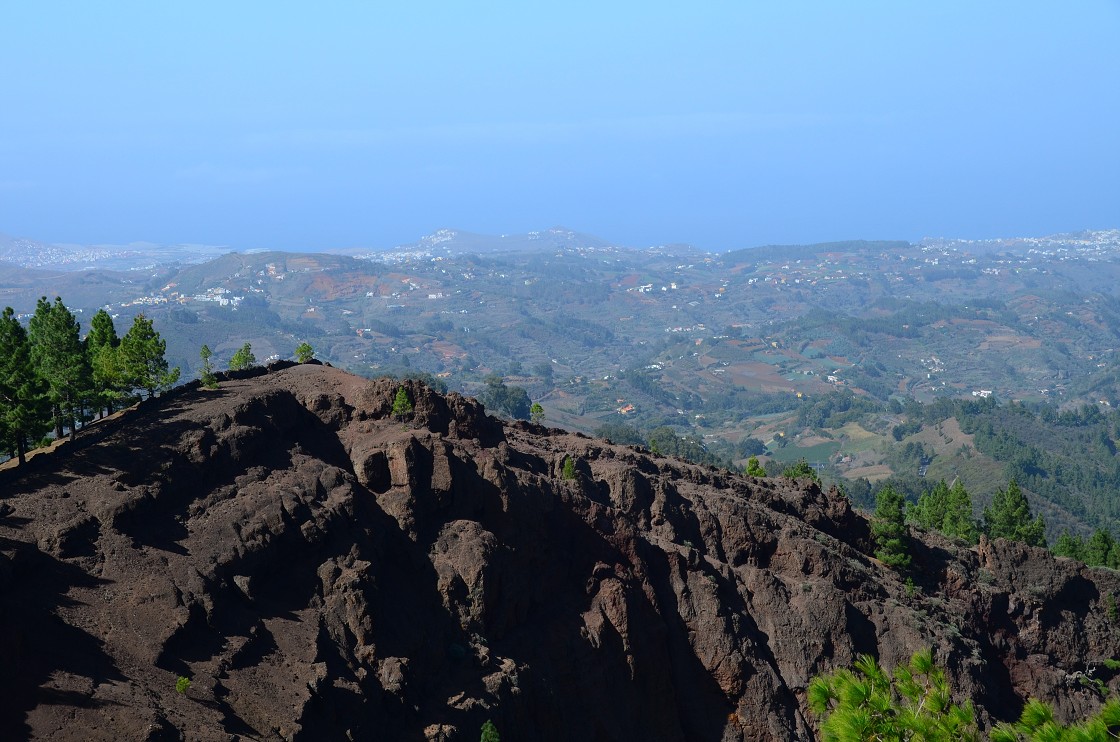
[0,365,1120,741]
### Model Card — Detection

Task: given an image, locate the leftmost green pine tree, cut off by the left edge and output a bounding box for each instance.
[0,307,50,464]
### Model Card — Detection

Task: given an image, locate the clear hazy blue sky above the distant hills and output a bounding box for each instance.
[0,0,1120,251]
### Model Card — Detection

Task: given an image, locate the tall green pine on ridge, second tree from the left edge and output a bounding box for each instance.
[28,296,93,438]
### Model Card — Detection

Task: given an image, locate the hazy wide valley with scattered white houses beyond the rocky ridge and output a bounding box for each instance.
[0,228,1120,538]
